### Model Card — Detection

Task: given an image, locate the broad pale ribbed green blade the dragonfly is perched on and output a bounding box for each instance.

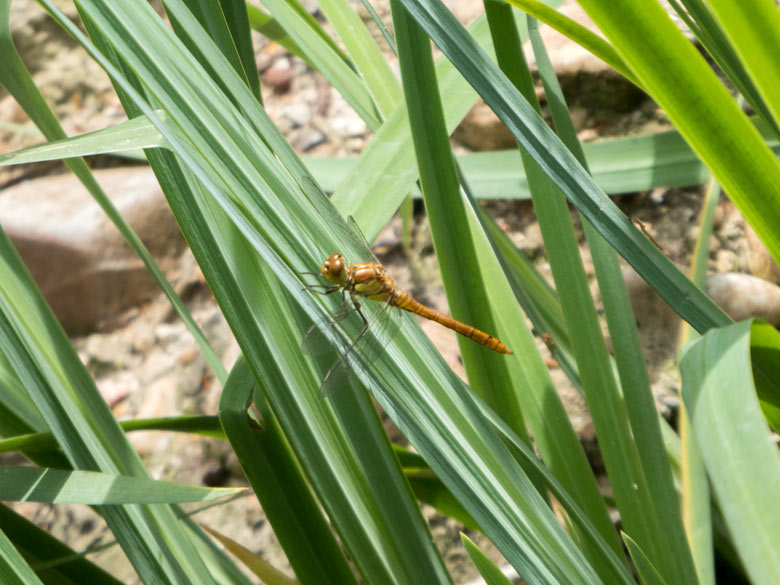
[53,0,616,583]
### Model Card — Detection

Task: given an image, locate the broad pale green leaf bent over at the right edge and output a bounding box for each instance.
[680,320,780,585]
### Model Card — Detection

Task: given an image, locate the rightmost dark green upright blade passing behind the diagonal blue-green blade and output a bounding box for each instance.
[529,12,694,580]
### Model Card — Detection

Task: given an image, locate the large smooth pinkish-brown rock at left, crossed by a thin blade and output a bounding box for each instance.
[0,168,184,334]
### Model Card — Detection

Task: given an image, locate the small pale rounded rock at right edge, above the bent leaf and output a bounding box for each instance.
[707,273,780,327]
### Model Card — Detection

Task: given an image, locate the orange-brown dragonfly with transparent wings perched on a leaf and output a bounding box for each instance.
[303,216,512,396]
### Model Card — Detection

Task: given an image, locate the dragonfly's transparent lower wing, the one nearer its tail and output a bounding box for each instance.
[320,296,401,398]
